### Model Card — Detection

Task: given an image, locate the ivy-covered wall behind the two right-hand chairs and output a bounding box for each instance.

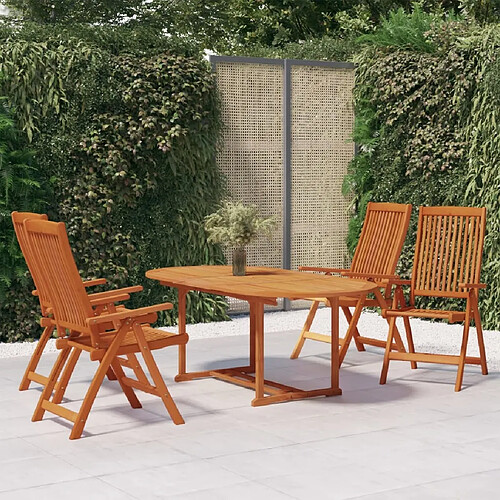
[344,10,500,329]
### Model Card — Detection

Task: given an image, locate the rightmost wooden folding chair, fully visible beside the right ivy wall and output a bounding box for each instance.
[380,207,488,392]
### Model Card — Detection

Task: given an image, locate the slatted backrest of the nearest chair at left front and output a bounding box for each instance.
[24,219,94,334]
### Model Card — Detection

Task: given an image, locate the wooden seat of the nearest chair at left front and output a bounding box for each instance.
[57,325,189,361]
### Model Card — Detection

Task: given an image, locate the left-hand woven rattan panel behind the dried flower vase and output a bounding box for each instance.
[216,63,283,312]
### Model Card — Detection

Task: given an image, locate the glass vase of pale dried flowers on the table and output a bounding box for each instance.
[205,200,276,276]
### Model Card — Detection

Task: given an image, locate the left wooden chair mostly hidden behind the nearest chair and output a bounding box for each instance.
[11,212,142,394]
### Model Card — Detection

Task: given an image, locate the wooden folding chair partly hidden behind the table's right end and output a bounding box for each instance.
[290,202,413,363]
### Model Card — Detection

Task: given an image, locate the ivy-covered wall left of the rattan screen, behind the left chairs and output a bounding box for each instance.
[0,27,227,341]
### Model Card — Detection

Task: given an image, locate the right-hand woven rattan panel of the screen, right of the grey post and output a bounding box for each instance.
[291,66,354,269]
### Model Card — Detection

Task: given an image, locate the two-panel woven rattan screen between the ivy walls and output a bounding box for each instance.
[214,58,354,312]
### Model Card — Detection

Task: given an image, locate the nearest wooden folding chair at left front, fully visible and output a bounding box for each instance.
[24,219,188,439]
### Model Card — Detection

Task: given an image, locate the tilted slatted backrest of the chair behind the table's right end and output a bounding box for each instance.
[351,202,411,274]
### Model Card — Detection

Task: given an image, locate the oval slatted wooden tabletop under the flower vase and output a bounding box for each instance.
[146,266,377,300]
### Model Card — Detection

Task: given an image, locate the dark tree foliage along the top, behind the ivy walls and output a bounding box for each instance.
[4,0,484,53]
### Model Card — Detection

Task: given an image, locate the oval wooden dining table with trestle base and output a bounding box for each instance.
[146,266,377,406]
